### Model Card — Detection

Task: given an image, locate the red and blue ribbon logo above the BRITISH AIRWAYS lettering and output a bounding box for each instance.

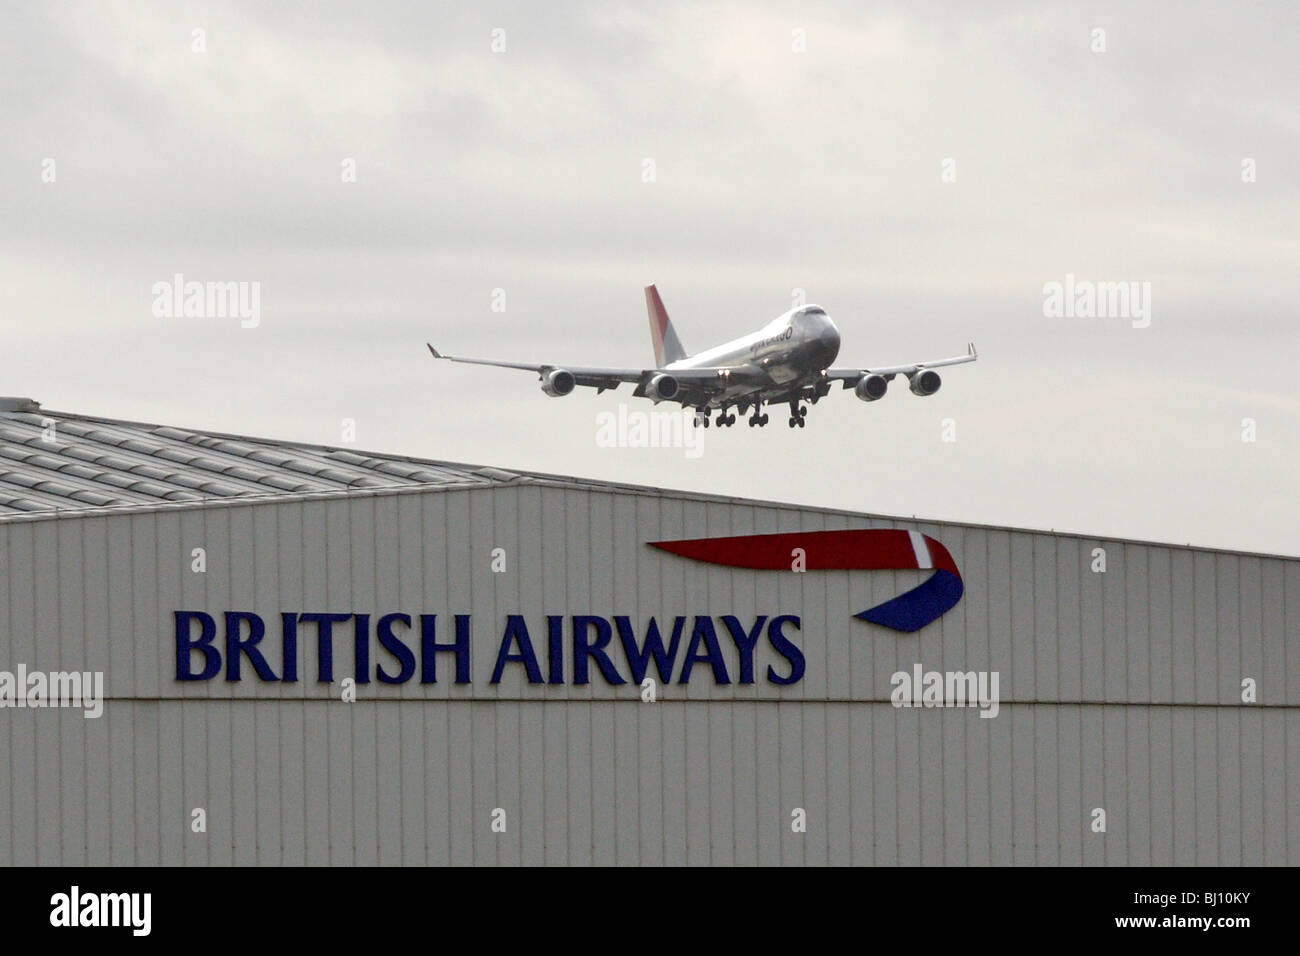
[650,528,965,633]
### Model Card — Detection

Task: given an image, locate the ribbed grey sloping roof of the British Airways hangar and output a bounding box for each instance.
[0,398,538,520]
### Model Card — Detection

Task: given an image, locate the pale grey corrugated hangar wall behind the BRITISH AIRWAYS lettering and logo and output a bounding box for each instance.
[0,483,1300,865]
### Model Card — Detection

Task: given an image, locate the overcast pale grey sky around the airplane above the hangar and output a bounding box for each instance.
[0,3,1300,554]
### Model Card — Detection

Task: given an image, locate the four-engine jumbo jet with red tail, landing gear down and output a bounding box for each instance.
[425,285,979,428]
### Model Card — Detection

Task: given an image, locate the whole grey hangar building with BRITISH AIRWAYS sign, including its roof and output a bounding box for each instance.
[0,398,1300,865]
